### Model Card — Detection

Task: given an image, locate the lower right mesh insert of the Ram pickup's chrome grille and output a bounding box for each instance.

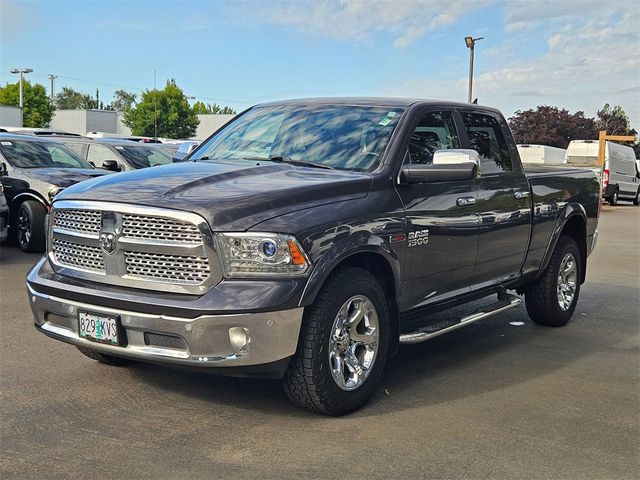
[124,251,210,285]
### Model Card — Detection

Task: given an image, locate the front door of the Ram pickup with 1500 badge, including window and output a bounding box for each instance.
[397,109,478,310]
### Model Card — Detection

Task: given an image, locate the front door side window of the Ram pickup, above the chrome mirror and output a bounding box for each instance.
[409,112,460,165]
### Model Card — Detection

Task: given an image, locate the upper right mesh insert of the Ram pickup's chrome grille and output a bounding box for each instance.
[122,213,202,243]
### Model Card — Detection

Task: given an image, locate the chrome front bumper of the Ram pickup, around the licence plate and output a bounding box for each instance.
[27,285,303,367]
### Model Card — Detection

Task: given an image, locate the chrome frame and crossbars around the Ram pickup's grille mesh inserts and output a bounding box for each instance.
[47,200,222,295]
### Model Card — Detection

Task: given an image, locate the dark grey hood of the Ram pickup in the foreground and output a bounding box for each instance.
[56,160,371,233]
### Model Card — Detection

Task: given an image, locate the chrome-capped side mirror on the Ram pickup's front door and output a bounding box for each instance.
[400,149,480,183]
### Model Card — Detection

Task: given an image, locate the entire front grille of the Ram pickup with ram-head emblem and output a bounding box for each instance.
[49,201,222,294]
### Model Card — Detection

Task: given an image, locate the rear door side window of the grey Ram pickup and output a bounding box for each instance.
[462,113,513,174]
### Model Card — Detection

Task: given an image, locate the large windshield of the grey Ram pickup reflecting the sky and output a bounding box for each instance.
[191,105,403,171]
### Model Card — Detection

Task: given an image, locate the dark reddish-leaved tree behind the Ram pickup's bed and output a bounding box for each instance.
[509,105,598,148]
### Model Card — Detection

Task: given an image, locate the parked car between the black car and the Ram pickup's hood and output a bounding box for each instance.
[41,137,172,172]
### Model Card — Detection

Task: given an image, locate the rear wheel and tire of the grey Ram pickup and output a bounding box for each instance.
[525,236,583,327]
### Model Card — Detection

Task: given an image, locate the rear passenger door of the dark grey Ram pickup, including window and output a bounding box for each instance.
[461,111,531,289]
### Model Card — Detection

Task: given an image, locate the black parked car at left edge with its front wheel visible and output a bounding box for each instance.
[0,133,107,252]
